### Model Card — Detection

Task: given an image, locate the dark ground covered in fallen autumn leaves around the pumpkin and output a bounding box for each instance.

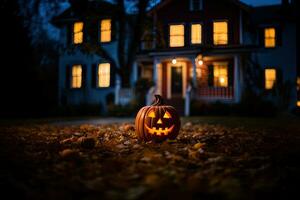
[0,116,300,200]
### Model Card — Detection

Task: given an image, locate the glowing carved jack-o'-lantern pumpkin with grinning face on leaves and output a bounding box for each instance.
[135,95,180,141]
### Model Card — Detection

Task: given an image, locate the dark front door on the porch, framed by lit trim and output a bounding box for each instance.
[171,66,182,97]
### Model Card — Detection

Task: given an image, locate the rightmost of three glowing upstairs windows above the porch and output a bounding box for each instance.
[213,21,228,45]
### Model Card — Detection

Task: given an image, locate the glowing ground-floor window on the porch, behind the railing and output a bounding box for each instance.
[214,64,228,87]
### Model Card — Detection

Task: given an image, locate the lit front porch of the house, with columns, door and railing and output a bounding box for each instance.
[138,55,241,115]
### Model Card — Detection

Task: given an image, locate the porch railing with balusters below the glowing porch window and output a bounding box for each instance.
[197,87,234,99]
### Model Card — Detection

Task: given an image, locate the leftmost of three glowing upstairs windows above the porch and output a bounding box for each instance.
[170,25,184,47]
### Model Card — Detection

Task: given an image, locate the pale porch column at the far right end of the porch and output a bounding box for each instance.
[234,55,241,103]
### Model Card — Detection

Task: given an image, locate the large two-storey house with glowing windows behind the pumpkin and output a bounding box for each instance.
[51,0,300,115]
